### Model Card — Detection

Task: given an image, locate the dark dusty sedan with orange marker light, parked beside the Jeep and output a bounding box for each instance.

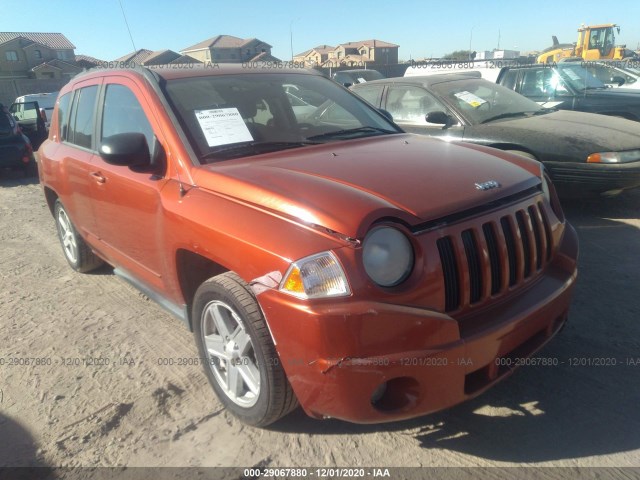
[351,71,640,195]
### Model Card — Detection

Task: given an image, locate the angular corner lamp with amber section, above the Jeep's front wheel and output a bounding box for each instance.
[280,252,351,299]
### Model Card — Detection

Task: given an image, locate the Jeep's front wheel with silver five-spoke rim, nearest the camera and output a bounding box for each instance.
[192,272,298,427]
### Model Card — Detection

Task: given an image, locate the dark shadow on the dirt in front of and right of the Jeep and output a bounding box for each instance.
[272,192,640,463]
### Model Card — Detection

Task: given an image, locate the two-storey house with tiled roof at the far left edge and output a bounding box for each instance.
[0,32,82,78]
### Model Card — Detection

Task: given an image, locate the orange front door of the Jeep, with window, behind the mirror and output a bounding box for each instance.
[91,77,166,288]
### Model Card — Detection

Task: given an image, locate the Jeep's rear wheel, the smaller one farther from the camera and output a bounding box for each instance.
[54,199,104,273]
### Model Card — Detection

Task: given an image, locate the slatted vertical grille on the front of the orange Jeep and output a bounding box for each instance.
[436,203,552,312]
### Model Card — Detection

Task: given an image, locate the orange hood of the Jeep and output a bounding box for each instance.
[194,134,540,238]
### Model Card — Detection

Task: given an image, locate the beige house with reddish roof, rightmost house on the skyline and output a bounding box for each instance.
[293,39,400,67]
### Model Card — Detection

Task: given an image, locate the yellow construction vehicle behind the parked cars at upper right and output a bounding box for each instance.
[537,23,636,63]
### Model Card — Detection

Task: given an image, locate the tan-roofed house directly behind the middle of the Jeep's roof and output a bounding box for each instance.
[180,35,280,63]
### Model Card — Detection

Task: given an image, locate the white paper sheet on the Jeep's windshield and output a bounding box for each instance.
[195,108,253,147]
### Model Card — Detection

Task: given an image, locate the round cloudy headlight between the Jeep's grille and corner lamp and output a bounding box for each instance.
[362,227,413,287]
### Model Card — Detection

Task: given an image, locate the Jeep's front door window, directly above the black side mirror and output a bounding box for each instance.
[101,83,153,151]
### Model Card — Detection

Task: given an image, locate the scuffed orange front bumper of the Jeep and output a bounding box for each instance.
[259,226,577,423]
